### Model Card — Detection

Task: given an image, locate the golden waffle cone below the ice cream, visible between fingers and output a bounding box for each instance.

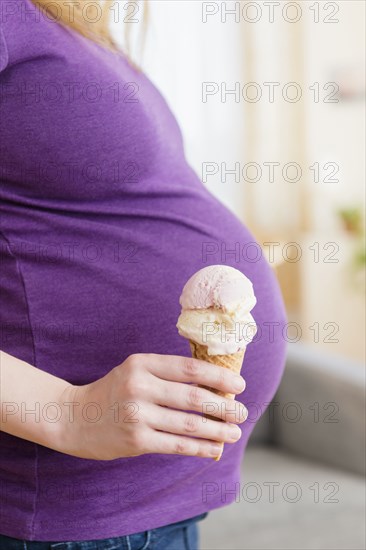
[189,340,245,461]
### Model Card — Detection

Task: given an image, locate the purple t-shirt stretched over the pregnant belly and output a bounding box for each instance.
[0,0,285,541]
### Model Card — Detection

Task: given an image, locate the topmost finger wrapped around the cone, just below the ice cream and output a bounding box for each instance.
[145,354,245,395]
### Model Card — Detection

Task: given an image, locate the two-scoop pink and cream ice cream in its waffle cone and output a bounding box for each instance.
[177,265,257,460]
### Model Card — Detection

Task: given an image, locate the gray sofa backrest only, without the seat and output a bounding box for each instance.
[251,343,365,475]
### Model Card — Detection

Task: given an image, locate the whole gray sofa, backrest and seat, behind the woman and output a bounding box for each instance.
[201,343,366,550]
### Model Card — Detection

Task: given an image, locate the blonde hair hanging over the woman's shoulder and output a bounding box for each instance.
[32,0,149,69]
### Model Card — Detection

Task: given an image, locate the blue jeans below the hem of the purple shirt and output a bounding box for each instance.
[0,513,207,550]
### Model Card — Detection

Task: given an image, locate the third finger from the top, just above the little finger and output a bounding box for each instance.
[148,406,242,443]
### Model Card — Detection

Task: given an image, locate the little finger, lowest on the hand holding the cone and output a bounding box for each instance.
[143,430,222,458]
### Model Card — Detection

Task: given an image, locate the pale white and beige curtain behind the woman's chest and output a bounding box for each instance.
[124,0,306,234]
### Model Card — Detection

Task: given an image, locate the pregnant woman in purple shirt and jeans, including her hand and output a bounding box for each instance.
[0,0,285,550]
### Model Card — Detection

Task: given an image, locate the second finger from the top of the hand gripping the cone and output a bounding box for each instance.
[150,380,248,424]
